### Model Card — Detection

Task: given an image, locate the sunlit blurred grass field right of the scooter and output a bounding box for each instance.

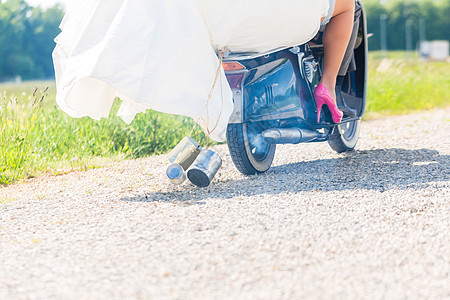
[367,52,450,118]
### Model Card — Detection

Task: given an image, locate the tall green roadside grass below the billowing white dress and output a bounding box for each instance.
[0,82,210,184]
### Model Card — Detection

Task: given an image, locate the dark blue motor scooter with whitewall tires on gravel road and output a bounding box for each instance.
[223,0,368,175]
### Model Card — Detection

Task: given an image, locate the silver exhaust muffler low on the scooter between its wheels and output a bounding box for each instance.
[261,128,327,144]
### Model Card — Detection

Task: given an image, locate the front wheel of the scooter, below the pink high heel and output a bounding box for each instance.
[328,120,361,153]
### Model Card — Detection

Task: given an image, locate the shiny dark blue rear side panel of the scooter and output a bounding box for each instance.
[227,49,312,123]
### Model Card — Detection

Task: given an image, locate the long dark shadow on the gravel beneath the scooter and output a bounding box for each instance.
[121,149,450,202]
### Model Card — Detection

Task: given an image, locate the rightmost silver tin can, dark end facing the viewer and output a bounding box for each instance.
[187,150,222,187]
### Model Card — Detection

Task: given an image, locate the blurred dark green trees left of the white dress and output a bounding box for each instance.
[0,0,63,80]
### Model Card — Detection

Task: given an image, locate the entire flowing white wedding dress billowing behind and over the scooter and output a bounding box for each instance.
[53,0,328,141]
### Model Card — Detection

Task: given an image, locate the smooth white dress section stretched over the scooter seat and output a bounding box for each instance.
[196,0,329,52]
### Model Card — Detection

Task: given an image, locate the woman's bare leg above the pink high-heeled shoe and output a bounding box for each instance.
[321,0,355,100]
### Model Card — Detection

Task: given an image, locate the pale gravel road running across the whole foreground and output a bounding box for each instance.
[0,109,450,299]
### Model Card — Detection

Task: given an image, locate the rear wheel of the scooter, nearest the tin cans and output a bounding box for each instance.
[227,123,276,175]
